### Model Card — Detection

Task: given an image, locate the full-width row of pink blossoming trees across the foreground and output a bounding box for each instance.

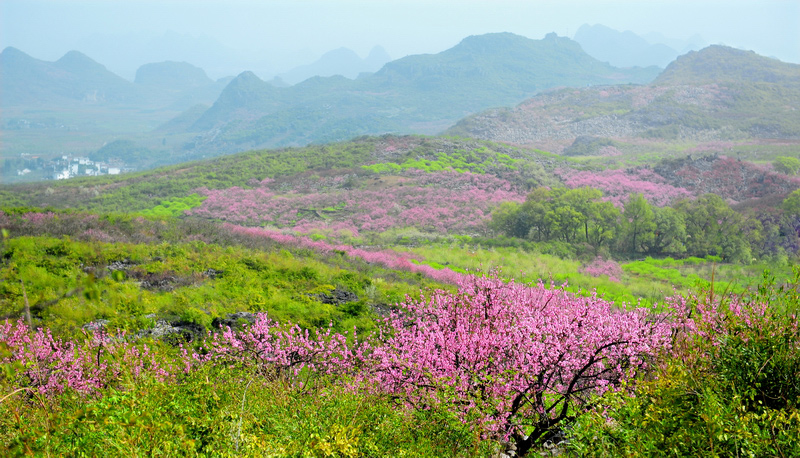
[0,268,800,455]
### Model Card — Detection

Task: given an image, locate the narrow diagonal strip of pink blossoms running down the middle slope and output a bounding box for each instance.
[225,224,461,283]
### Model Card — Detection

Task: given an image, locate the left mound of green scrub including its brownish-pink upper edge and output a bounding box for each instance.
[0,213,438,334]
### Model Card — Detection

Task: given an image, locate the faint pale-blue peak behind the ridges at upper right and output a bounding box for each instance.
[574,24,680,68]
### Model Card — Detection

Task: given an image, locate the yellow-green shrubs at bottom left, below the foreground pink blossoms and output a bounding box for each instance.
[0,366,491,458]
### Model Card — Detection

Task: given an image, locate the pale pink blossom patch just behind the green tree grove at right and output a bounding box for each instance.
[556,168,692,208]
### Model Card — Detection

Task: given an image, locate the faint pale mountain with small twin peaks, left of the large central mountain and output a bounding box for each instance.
[278,46,391,84]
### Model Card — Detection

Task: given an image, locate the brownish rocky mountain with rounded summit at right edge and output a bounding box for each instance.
[447,46,800,148]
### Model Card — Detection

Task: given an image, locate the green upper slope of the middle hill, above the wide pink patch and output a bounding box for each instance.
[0,136,561,212]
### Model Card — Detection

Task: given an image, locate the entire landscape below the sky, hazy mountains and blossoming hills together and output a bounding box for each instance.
[0,20,800,457]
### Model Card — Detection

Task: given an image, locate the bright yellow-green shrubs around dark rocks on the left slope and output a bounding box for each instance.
[0,236,419,333]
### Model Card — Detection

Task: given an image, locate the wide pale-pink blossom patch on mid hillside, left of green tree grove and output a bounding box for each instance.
[188,171,524,234]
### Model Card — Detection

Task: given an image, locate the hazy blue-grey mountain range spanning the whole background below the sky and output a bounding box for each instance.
[0,26,800,179]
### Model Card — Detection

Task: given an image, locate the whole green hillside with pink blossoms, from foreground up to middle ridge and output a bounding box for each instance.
[0,131,800,457]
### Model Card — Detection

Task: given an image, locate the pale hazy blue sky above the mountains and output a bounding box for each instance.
[0,0,800,79]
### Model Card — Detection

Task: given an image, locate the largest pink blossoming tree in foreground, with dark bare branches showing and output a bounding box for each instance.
[367,276,673,440]
